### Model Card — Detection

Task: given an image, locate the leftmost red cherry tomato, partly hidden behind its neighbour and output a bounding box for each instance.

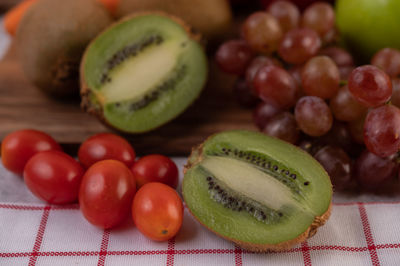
[1,129,61,175]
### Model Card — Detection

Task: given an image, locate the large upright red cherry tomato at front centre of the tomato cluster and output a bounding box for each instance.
[79,160,136,229]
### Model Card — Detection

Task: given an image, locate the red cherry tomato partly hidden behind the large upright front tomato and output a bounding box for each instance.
[78,133,136,168]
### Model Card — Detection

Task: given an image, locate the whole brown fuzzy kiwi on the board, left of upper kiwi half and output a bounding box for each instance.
[16,0,112,97]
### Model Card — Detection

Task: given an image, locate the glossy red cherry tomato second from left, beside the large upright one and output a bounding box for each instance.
[24,151,84,204]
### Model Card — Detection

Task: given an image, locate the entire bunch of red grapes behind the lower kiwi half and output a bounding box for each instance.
[216,1,400,190]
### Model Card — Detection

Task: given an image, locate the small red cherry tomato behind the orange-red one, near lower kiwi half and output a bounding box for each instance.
[132,154,179,188]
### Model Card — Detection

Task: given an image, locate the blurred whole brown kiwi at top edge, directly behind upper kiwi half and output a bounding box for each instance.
[117,0,233,40]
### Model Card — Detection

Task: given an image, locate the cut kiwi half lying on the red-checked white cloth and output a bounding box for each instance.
[182,131,332,252]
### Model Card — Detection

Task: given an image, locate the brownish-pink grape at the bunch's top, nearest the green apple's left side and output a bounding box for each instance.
[301,2,335,36]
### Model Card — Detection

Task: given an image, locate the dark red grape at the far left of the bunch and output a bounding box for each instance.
[215,40,253,76]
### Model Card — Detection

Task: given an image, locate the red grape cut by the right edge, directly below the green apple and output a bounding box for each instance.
[371,48,400,78]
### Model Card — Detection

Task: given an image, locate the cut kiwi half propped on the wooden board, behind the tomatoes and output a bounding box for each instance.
[81,13,207,133]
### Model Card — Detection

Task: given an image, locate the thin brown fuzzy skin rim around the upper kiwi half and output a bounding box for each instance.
[80,11,205,134]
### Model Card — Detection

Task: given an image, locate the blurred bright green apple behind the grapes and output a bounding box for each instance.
[336,0,400,61]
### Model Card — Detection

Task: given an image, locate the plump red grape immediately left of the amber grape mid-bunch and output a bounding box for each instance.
[253,66,297,108]
